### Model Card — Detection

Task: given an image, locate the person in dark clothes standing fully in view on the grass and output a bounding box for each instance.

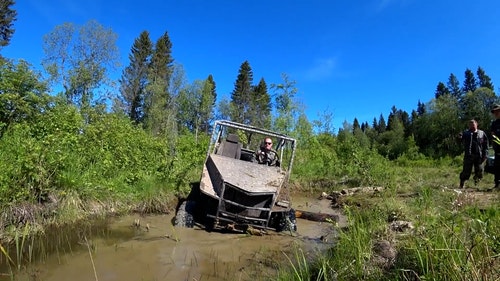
[459,118,488,188]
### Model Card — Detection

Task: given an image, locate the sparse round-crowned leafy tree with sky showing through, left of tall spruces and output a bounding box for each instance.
[42,20,118,108]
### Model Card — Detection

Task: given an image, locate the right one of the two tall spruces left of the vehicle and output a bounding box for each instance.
[144,32,175,135]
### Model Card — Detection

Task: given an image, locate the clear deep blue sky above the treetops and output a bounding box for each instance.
[1,0,500,129]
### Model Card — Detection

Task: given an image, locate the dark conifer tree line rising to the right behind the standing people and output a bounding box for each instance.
[342,66,499,159]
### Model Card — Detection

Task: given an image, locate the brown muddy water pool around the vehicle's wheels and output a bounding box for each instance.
[6,195,344,281]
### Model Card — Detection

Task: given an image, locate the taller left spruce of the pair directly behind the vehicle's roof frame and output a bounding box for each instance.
[230,61,253,124]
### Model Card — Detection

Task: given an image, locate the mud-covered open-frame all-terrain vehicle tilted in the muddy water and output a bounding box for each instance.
[174,120,296,231]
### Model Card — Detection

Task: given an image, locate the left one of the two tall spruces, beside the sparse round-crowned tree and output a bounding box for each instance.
[120,31,153,123]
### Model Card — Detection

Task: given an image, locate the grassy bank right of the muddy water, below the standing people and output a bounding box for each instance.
[278,159,500,280]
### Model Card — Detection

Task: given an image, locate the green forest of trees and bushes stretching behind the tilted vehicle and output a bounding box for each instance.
[0,0,500,278]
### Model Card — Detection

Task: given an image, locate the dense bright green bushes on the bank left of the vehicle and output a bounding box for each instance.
[0,98,184,203]
